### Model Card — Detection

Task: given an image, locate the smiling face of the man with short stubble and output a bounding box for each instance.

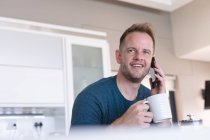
[116,32,154,83]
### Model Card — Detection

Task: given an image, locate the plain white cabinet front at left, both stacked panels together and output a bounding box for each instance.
[0,29,64,106]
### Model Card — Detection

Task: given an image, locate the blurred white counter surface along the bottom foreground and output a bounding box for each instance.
[0,127,210,140]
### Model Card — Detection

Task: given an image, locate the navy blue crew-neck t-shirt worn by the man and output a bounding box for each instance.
[71,76,151,127]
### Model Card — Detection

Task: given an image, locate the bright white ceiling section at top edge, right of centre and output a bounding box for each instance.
[118,0,193,12]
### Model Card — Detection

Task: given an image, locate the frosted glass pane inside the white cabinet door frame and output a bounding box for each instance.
[72,45,103,97]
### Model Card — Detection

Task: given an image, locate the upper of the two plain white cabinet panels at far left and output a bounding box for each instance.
[0,29,63,69]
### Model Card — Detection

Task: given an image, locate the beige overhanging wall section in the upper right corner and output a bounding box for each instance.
[171,0,210,56]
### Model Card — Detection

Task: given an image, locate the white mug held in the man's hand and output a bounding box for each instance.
[147,93,172,123]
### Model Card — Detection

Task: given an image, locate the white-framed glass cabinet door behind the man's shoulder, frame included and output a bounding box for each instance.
[67,36,111,98]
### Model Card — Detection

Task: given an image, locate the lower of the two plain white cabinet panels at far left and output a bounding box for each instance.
[0,66,64,106]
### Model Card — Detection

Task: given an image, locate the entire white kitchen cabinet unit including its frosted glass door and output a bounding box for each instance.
[0,19,111,134]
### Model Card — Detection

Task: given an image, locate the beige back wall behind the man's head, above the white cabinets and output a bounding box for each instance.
[0,0,210,122]
